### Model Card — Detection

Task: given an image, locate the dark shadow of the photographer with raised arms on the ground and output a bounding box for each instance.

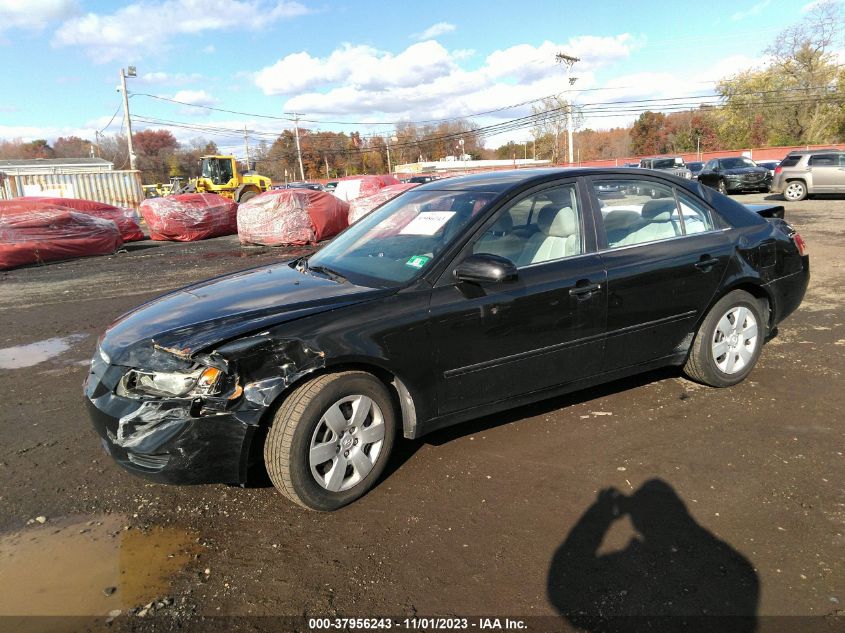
[547,479,760,633]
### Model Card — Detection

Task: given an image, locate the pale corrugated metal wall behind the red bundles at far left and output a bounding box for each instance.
[0,170,144,209]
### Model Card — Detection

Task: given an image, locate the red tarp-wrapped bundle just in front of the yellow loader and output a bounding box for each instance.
[141,193,238,242]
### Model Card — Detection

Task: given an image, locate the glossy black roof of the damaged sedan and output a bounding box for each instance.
[414,167,678,194]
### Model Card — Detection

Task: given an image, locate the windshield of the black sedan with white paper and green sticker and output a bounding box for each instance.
[308,191,493,286]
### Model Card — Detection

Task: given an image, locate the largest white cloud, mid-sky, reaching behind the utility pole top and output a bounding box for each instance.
[254,34,639,141]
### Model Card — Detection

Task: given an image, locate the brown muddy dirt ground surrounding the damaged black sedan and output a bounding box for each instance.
[0,195,845,630]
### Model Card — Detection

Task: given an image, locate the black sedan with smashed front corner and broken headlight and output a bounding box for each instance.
[85,169,809,510]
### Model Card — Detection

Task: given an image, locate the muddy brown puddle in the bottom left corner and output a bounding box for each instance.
[0,515,200,618]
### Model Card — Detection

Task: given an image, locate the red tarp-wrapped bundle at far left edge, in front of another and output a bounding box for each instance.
[0,205,123,269]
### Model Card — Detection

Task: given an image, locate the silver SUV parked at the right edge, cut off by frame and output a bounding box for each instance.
[772,149,845,201]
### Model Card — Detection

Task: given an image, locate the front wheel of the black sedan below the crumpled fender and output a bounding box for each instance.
[264,371,396,511]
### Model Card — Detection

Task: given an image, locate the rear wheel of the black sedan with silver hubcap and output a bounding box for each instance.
[684,290,765,387]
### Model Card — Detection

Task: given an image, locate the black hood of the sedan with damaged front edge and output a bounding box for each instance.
[101,263,394,366]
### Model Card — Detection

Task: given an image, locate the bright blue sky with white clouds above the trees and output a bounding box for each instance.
[0,0,836,154]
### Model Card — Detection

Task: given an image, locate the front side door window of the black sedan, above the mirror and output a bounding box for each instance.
[472,184,582,268]
